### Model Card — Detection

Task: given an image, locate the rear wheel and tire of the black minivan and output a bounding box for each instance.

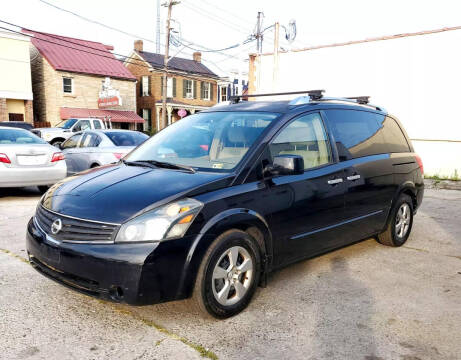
[378,194,413,247]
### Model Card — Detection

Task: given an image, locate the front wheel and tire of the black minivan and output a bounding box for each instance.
[192,229,261,319]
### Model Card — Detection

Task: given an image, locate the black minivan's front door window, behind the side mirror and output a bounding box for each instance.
[269,113,331,169]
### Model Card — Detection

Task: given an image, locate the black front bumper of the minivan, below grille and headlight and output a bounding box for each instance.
[26,219,195,305]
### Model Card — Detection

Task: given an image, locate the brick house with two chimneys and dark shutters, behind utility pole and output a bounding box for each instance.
[125,40,219,131]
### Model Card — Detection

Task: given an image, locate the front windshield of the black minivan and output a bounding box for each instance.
[125,111,279,171]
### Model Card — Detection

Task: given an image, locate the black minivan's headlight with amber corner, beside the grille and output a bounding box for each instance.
[115,199,203,242]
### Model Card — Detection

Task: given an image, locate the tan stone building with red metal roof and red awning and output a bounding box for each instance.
[26,30,144,129]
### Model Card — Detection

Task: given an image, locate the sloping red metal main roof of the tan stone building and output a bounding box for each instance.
[23,30,136,80]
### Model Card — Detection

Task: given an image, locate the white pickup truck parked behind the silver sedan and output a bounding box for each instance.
[33,118,111,147]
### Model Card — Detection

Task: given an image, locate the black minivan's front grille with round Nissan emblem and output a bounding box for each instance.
[35,205,118,242]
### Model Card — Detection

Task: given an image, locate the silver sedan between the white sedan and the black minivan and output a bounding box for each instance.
[61,130,149,175]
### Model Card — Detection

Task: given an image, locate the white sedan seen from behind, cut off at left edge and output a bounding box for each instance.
[0,126,67,192]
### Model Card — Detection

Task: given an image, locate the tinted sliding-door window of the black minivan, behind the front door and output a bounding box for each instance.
[326,110,388,161]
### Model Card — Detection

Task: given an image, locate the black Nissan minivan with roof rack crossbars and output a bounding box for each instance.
[27,92,424,318]
